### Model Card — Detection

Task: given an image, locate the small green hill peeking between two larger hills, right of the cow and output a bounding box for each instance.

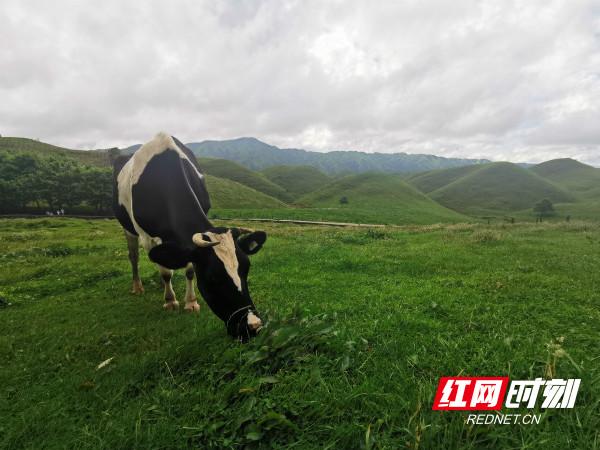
[262,166,331,199]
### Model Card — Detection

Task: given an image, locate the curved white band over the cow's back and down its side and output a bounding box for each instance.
[117,132,202,252]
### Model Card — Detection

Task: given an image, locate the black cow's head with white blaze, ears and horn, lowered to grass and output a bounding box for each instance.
[149,228,267,340]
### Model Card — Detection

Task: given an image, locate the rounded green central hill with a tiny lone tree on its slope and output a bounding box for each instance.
[298,173,466,223]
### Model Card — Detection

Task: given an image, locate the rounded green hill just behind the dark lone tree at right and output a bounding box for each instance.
[430,162,575,215]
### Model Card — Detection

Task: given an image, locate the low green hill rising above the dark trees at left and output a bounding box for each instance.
[0,137,109,167]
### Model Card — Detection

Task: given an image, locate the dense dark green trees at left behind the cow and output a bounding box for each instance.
[0,152,112,215]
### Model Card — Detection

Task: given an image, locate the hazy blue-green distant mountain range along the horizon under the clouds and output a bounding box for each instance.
[123,137,489,175]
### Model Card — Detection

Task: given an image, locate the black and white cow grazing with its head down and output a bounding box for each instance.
[114,133,267,340]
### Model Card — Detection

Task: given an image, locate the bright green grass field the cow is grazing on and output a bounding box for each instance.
[0,218,600,449]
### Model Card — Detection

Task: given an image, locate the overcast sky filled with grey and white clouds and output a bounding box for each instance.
[0,0,600,166]
